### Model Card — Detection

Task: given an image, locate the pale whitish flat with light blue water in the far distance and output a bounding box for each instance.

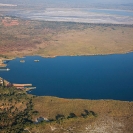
[5,8,133,25]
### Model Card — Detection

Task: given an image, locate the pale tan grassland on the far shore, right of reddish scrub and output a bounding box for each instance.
[38,23,133,56]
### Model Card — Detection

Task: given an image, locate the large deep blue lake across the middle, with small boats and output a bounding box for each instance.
[0,53,133,101]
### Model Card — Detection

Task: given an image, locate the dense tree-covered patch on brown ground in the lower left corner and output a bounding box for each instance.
[0,87,38,133]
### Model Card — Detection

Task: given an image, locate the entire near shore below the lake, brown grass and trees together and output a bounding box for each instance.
[0,87,133,133]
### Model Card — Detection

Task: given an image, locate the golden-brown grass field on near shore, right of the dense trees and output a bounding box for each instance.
[29,97,133,133]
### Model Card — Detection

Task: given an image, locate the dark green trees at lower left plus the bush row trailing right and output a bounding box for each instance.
[0,87,96,133]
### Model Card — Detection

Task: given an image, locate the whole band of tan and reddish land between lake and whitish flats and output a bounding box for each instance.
[0,17,133,63]
